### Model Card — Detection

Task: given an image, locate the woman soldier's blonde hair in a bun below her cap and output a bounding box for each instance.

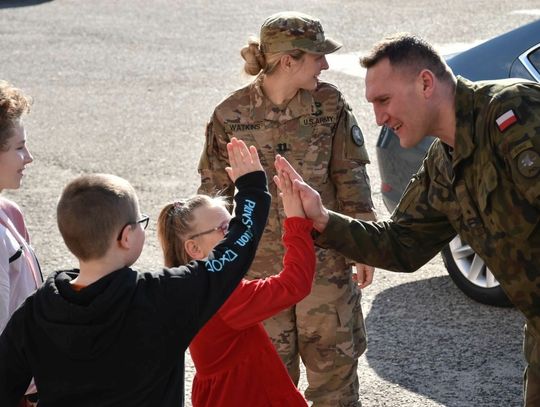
[240,37,306,76]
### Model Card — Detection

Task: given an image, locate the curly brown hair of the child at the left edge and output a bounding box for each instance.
[0,81,32,151]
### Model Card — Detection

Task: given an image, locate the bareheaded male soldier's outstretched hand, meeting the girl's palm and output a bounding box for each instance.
[274,155,330,232]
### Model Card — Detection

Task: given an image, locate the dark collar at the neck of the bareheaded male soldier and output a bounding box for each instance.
[453,76,476,167]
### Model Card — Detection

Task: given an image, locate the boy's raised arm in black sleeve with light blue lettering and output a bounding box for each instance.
[162,138,271,347]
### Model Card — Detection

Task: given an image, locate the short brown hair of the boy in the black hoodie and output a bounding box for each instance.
[56,174,139,261]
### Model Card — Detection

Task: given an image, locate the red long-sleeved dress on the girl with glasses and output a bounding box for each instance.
[189,218,315,407]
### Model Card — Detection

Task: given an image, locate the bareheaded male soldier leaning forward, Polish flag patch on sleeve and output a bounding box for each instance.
[276,35,540,406]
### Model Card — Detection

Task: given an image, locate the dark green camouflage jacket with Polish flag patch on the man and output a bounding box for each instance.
[317,78,540,406]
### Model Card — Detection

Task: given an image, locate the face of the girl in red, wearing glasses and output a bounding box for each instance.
[188,204,232,260]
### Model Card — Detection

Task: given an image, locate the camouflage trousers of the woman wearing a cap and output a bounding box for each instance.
[264,264,367,407]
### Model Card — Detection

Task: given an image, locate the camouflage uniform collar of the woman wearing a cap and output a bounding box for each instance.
[250,74,316,124]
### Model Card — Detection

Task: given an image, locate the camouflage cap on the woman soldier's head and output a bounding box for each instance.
[260,11,341,54]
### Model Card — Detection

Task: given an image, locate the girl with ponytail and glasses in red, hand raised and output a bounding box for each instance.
[158,171,315,407]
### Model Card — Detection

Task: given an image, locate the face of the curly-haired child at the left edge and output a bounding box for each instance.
[0,121,34,190]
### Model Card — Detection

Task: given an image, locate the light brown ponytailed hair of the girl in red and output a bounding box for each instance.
[157,195,229,267]
